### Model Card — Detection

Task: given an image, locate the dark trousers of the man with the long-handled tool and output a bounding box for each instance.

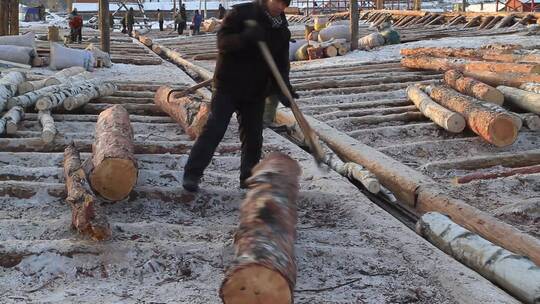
[184,90,264,180]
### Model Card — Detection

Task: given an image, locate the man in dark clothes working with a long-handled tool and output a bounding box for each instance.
[183,0,297,191]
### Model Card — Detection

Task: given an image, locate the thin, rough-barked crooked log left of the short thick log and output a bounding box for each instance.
[64,143,112,241]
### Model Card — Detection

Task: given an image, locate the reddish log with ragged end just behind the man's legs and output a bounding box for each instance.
[154,86,210,139]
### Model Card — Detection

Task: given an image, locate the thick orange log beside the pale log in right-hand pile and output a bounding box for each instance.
[426,85,518,147]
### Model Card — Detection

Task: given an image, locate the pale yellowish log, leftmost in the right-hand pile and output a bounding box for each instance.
[407,86,465,133]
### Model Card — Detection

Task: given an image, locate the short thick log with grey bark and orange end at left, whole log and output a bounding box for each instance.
[89,105,138,201]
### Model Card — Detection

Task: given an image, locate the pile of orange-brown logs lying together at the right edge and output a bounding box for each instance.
[401,45,540,147]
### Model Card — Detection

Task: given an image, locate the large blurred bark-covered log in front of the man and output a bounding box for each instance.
[220,153,301,304]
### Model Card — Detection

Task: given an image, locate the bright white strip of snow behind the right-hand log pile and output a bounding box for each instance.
[291,34,540,67]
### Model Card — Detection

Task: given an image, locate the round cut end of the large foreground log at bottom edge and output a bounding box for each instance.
[221,265,292,304]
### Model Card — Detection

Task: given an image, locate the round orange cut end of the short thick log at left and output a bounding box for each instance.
[90,158,137,201]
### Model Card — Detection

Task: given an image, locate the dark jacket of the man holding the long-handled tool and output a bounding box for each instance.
[214,2,291,100]
